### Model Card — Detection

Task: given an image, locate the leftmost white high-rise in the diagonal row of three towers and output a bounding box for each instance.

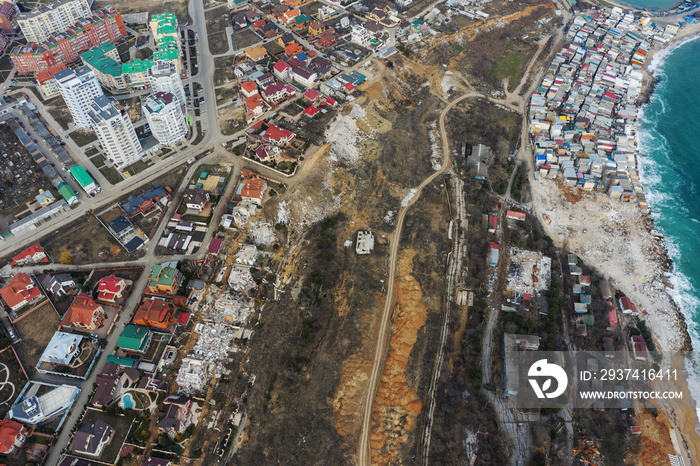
[54,66,104,128]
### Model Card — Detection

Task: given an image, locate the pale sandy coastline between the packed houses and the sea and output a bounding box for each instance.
[530,0,700,464]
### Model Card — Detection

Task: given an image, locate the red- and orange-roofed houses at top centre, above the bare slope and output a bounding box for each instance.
[229,0,448,126]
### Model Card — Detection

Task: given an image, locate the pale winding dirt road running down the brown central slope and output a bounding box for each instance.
[357,92,476,465]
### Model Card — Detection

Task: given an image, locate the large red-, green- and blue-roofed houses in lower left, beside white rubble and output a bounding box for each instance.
[0,240,241,464]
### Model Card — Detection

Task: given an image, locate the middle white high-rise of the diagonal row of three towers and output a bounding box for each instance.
[88,96,143,169]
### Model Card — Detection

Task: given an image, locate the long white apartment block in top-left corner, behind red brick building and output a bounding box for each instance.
[17,0,92,43]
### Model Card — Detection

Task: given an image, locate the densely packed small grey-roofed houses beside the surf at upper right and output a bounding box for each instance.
[529,7,678,211]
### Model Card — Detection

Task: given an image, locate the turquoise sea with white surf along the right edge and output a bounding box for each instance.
[637,37,700,418]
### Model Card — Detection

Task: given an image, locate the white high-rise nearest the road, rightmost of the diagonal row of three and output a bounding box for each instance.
[142,92,187,146]
